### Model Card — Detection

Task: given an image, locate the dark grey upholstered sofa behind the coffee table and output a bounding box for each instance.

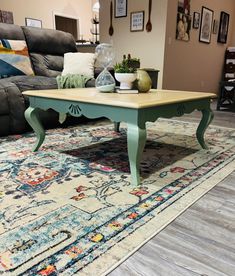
[0,23,99,136]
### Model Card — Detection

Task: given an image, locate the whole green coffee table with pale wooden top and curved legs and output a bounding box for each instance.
[23,88,215,185]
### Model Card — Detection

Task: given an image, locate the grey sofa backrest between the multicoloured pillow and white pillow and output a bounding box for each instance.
[22,27,77,77]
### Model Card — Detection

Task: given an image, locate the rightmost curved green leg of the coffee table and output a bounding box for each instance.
[196,108,214,149]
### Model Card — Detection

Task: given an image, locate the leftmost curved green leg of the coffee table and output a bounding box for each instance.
[25,107,45,151]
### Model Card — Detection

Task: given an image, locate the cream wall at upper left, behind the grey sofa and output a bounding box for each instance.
[0,0,93,40]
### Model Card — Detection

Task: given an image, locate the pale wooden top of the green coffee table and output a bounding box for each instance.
[23,88,216,108]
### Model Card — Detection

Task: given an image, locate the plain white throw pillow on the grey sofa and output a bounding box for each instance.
[62,53,96,78]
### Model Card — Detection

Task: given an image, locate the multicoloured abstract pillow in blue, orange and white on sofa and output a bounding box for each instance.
[0,39,34,78]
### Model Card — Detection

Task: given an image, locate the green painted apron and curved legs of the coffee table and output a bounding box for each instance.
[25,96,213,185]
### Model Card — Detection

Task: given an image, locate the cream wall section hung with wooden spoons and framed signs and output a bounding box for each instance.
[100,0,168,88]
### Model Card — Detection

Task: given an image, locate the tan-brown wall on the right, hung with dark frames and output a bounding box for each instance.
[163,0,235,93]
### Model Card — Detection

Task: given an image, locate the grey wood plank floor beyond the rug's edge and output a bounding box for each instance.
[109,103,235,276]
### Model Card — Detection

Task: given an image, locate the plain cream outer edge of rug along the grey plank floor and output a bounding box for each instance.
[80,160,235,276]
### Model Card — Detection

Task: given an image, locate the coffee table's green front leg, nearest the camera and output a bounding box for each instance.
[127,124,146,185]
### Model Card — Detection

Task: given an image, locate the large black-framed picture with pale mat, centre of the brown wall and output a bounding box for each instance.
[199,7,214,44]
